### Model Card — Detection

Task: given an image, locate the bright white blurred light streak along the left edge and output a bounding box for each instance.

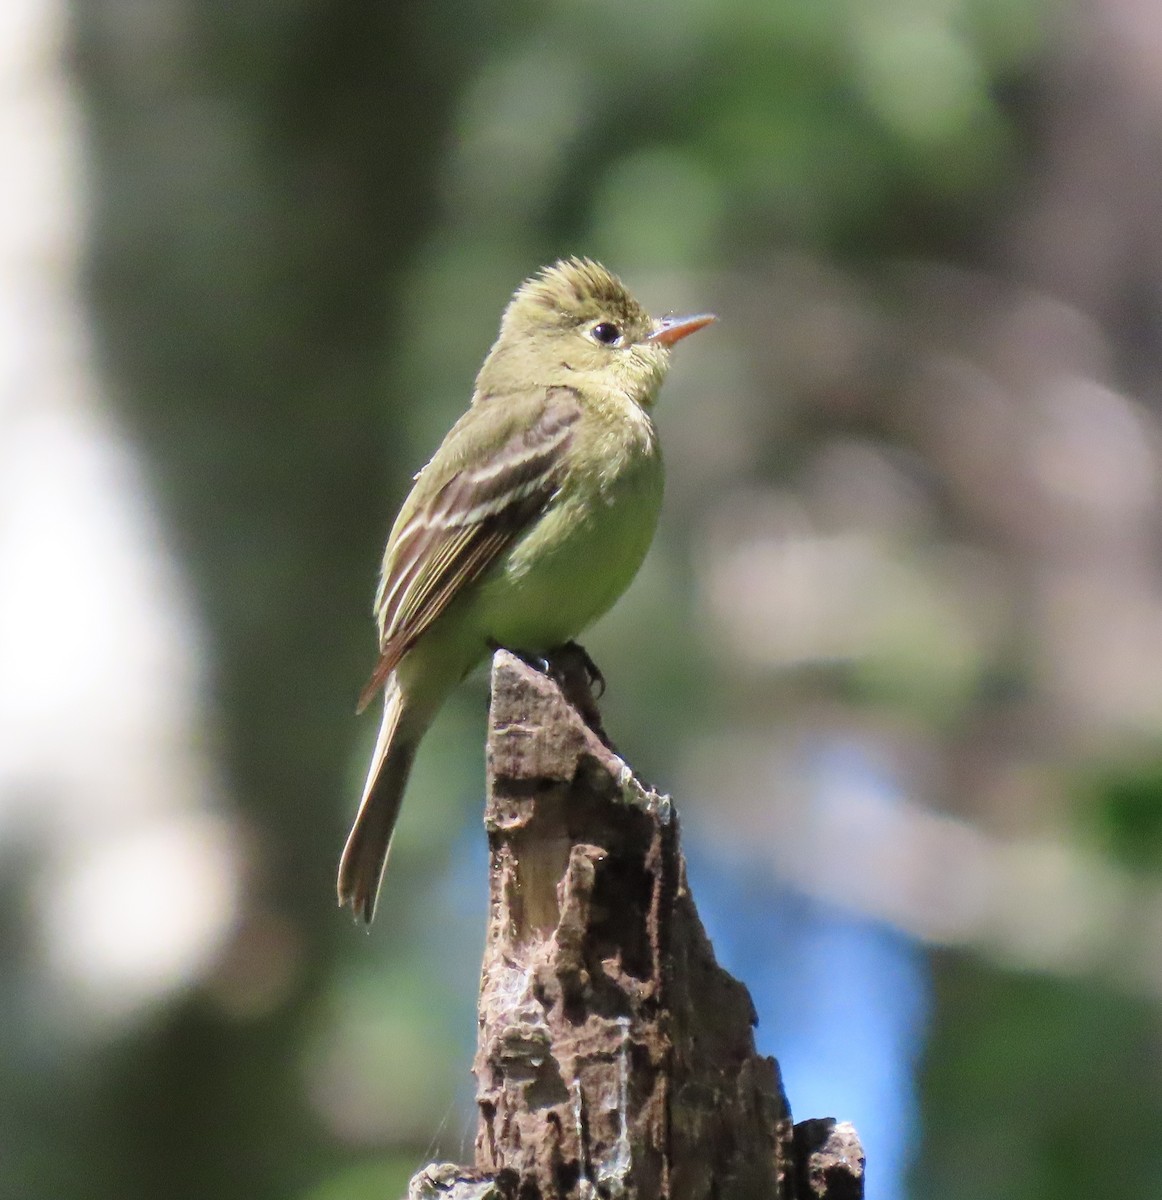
[0,0,239,1031]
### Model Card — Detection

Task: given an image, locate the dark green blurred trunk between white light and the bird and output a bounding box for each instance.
[72,0,480,1200]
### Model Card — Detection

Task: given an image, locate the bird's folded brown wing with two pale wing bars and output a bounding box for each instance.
[359,388,581,712]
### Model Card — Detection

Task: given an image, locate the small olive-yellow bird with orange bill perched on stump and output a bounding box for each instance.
[337,257,715,924]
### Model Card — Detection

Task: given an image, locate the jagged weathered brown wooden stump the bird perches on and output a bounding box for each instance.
[412,652,862,1200]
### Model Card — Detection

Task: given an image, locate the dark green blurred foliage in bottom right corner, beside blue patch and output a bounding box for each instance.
[912,955,1162,1200]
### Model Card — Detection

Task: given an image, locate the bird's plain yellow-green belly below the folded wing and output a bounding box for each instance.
[470,460,661,650]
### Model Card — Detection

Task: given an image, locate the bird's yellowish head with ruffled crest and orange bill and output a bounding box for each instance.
[479,258,714,407]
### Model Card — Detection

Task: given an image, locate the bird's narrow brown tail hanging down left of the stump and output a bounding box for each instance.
[337,676,423,925]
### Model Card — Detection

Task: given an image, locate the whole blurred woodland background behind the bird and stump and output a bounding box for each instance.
[0,0,1162,1200]
